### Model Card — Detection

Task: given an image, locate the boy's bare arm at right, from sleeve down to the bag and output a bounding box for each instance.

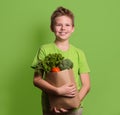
[79,73,90,101]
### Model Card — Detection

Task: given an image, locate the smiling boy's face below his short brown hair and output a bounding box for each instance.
[53,16,74,40]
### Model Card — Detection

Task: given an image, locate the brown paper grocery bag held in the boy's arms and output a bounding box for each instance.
[46,69,80,109]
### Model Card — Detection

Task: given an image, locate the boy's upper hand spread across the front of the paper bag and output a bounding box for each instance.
[57,83,76,97]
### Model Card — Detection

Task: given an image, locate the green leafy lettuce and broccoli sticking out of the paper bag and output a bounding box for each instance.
[31,53,73,74]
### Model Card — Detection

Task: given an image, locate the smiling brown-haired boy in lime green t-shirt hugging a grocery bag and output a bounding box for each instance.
[32,7,90,115]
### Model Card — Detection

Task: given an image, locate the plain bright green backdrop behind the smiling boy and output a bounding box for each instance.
[0,0,120,115]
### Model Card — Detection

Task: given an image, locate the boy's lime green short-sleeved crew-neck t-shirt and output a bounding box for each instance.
[32,43,90,111]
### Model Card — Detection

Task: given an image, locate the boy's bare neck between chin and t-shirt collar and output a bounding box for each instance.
[55,40,69,51]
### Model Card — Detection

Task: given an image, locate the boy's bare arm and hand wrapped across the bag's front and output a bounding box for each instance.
[33,72,76,97]
